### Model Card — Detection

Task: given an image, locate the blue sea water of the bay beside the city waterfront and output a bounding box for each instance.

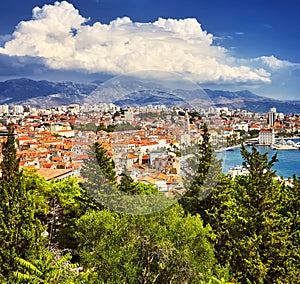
[216,139,300,178]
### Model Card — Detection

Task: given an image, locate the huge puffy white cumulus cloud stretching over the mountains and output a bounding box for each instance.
[0,1,274,83]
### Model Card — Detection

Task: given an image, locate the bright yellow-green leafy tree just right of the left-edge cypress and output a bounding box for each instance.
[23,170,101,249]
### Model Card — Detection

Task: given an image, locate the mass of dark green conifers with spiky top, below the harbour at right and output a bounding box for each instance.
[201,147,300,283]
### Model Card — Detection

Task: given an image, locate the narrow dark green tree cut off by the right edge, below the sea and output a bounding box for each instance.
[266,175,300,283]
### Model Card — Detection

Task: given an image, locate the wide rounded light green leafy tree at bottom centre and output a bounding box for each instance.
[76,205,223,283]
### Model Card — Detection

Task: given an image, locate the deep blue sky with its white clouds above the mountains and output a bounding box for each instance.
[0,0,300,100]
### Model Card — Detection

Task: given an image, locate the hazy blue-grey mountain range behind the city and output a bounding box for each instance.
[0,78,300,113]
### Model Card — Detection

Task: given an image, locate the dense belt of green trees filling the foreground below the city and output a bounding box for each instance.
[0,127,300,284]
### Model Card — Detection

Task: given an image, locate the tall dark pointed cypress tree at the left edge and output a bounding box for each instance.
[0,126,45,281]
